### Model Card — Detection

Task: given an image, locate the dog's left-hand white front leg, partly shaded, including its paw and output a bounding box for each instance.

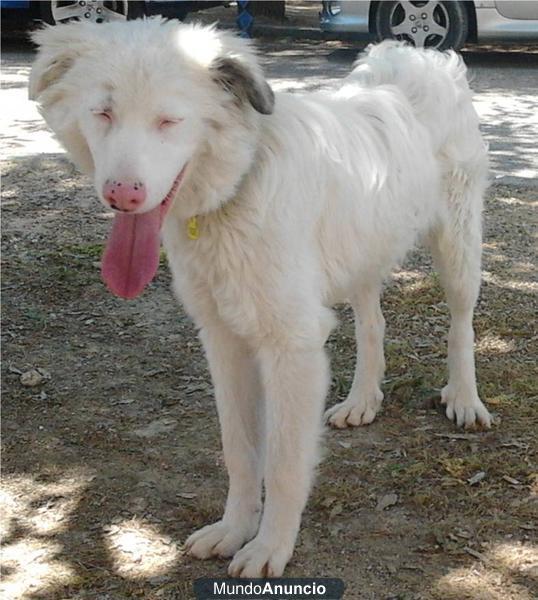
[186,323,262,558]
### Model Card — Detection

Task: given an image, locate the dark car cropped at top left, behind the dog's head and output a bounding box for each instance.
[0,0,223,25]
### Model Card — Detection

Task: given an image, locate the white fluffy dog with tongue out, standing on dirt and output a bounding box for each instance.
[30,19,490,577]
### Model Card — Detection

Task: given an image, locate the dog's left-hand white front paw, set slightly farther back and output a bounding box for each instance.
[185,521,257,559]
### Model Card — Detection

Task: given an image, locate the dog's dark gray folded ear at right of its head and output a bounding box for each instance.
[213,58,275,115]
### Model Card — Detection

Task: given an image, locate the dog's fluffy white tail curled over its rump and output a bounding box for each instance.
[347,41,484,163]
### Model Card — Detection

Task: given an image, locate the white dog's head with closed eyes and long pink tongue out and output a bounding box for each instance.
[30,18,274,297]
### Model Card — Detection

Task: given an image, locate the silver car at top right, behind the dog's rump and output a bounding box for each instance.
[320,0,538,50]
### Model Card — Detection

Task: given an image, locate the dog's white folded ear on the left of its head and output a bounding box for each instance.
[28,23,88,100]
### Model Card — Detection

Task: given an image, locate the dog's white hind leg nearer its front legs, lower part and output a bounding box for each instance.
[325,282,385,428]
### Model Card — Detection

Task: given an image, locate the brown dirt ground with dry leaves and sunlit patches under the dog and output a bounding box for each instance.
[2,150,538,600]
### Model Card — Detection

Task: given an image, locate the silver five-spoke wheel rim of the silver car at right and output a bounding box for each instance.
[389,0,450,48]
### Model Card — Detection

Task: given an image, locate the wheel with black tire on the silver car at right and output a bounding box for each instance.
[374,0,469,50]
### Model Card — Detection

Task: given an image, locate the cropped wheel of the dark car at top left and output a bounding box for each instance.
[39,1,146,25]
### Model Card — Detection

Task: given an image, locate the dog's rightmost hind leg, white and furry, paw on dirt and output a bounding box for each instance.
[430,173,491,428]
